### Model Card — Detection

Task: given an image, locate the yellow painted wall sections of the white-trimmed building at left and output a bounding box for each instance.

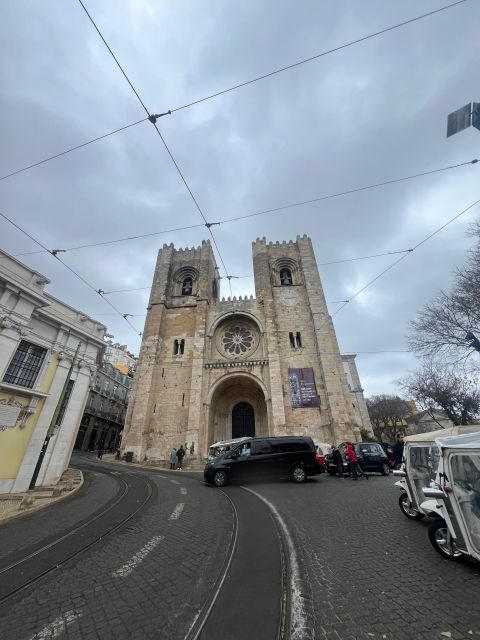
[0,355,58,480]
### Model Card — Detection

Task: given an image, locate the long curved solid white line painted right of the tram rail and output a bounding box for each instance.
[242,487,312,640]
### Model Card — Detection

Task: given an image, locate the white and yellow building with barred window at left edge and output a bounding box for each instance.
[0,251,105,493]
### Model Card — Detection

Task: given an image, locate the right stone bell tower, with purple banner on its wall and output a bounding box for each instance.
[252,235,358,442]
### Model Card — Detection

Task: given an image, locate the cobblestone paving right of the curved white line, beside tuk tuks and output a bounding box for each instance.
[249,475,480,640]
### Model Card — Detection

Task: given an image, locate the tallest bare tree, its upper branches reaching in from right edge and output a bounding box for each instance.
[407,221,480,363]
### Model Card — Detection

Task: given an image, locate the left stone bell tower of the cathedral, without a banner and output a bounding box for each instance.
[122,240,219,461]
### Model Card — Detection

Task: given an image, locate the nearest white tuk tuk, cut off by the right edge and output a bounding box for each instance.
[421,427,480,561]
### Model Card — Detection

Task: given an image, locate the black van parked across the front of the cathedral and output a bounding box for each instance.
[203,436,321,487]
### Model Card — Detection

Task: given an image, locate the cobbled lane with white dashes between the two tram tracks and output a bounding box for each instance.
[0,463,232,640]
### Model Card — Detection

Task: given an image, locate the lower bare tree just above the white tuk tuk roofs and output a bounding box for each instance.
[399,360,480,425]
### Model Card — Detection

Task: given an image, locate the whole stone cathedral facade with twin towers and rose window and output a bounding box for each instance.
[122,236,370,462]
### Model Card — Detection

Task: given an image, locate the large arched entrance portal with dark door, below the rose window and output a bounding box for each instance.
[206,372,269,447]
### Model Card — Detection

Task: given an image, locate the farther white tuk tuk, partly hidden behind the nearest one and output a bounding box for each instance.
[393,426,479,520]
